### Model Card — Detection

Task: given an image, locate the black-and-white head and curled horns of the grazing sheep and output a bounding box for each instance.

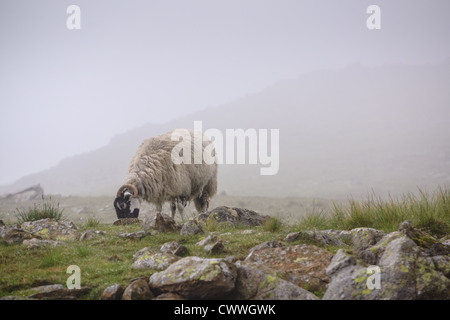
[114,184,140,219]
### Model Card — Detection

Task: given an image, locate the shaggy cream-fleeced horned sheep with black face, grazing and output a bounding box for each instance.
[114,129,217,221]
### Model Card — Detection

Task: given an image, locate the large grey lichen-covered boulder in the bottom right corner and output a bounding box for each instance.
[323,222,450,300]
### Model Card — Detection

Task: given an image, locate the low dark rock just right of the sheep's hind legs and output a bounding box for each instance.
[197,206,269,227]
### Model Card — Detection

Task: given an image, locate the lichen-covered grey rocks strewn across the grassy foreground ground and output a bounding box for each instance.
[0,207,450,300]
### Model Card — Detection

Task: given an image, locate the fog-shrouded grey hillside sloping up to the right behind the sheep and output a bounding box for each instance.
[0,60,450,198]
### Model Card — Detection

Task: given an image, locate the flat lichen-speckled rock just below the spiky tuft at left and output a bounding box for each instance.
[21,218,80,241]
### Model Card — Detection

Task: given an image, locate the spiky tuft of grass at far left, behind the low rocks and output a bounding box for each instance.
[16,196,64,223]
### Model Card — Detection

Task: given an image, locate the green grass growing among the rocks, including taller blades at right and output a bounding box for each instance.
[0,188,450,299]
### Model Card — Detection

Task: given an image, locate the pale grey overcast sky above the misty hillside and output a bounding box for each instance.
[0,0,450,184]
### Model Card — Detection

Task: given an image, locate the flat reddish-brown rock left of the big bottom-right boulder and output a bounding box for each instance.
[244,244,333,291]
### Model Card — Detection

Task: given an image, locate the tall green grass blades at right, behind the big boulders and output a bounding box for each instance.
[296,187,450,236]
